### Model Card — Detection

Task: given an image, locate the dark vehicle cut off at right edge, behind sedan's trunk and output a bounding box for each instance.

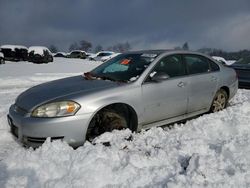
[229,56,250,89]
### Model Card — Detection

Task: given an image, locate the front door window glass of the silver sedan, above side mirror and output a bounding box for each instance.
[148,55,186,78]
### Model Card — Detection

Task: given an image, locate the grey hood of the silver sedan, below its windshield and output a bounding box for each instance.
[16,76,121,111]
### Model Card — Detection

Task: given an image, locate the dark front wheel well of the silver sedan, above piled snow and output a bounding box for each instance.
[86,109,129,141]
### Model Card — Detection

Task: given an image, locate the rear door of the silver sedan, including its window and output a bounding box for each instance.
[183,54,219,113]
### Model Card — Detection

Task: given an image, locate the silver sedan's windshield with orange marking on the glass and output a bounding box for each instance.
[90,53,157,82]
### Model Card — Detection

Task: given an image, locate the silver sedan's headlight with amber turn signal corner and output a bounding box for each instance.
[31,101,80,117]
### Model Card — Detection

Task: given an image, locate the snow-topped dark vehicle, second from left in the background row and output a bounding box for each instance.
[28,46,53,63]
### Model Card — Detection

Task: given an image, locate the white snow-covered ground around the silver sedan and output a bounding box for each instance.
[0,58,250,188]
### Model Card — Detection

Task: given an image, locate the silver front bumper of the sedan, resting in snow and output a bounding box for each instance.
[7,105,92,147]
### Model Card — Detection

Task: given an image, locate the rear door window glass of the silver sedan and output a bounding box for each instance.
[184,54,210,74]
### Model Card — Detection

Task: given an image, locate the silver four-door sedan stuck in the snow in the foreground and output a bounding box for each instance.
[8,50,238,147]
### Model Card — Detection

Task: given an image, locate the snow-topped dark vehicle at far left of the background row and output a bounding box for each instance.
[1,45,28,61]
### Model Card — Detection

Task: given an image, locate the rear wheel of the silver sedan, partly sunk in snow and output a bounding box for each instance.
[210,89,228,112]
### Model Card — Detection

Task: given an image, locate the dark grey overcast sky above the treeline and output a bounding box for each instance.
[0,0,250,51]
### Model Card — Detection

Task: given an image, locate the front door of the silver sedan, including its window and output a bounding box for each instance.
[142,55,187,124]
